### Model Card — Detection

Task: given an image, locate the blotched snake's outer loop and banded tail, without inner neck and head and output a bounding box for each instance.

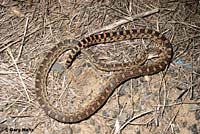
[35,29,173,123]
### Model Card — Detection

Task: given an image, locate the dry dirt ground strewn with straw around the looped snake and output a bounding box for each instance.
[0,0,200,134]
